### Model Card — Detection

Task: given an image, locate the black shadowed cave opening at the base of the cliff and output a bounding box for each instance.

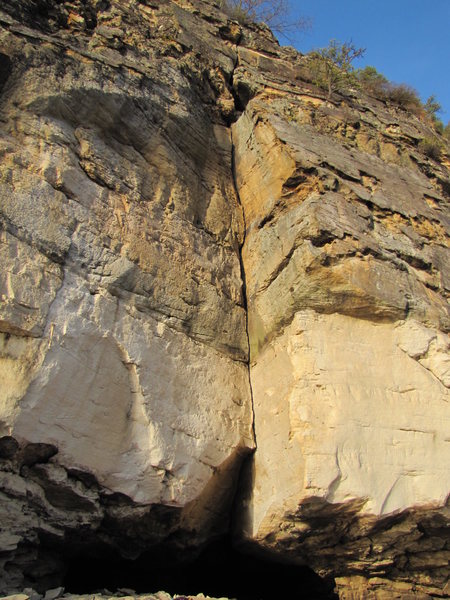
[63,538,337,600]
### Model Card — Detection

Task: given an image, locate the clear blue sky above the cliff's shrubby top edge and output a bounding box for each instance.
[280,0,450,124]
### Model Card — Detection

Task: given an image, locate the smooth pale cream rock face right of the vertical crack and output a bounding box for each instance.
[248,311,449,516]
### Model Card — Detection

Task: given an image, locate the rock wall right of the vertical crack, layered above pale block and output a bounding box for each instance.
[233,43,450,598]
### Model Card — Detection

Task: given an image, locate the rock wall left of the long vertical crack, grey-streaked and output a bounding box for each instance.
[0,1,254,592]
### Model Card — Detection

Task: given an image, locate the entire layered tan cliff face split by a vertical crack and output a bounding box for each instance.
[0,0,450,598]
